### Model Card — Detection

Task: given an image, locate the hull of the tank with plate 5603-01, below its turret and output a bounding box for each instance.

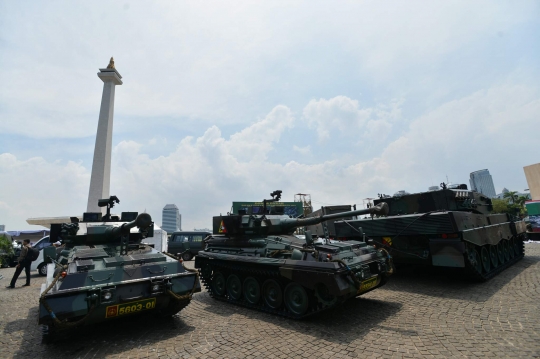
[38,245,201,342]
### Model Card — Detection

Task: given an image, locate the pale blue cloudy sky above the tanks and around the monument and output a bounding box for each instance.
[0,0,540,230]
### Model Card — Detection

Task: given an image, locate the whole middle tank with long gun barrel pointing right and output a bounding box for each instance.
[195,191,393,318]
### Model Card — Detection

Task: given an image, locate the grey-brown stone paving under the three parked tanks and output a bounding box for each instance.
[0,243,540,358]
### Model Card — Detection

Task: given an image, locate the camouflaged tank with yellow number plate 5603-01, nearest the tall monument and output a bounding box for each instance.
[38,196,201,342]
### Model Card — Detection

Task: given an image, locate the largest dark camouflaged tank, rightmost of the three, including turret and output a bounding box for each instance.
[334,183,526,281]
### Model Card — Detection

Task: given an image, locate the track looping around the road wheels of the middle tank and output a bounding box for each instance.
[199,257,364,319]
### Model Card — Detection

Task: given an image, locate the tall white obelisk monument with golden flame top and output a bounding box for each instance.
[86,57,122,212]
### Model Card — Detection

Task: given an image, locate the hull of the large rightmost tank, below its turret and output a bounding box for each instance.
[335,211,525,280]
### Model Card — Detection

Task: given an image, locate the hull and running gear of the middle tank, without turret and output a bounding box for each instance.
[195,238,392,319]
